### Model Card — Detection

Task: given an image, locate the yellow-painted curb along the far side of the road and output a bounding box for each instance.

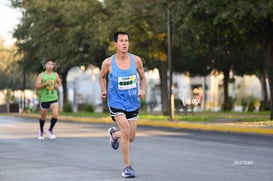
[12,114,273,135]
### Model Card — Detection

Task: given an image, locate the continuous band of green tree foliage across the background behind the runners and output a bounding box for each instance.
[5,0,273,119]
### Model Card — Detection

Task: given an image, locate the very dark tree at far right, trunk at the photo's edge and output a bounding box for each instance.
[193,0,273,117]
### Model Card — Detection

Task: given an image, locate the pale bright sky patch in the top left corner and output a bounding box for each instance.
[0,0,21,46]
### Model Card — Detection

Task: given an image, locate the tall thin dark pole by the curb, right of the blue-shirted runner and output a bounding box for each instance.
[167,2,174,121]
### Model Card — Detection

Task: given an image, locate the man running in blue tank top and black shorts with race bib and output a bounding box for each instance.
[99,32,146,178]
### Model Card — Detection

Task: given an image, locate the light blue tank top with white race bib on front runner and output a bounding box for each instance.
[108,54,140,111]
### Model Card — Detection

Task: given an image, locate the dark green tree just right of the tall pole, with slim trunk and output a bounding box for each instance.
[172,0,251,110]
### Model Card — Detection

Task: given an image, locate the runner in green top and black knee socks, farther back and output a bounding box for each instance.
[35,59,62,140]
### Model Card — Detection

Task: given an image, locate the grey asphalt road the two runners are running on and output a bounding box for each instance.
[0,116,273,181]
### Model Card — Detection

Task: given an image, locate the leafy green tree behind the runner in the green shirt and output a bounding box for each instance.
[11,0,106,100]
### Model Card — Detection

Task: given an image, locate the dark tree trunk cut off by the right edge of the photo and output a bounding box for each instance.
[265,42,273,120]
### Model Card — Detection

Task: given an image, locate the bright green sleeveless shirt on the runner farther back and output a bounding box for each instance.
[40,72,58,102]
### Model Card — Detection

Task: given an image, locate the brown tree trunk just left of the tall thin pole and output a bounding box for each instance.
[159,61,169,115]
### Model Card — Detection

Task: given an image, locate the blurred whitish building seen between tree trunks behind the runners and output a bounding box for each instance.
[67,66,269,111]
